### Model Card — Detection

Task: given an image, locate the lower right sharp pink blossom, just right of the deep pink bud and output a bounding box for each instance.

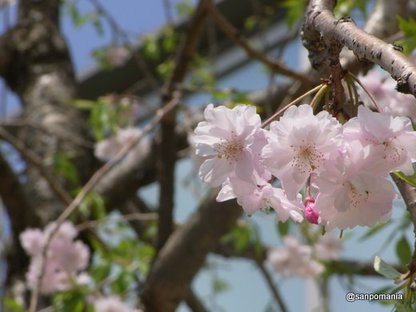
[315,142,396,230]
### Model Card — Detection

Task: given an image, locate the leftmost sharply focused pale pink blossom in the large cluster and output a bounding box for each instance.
[193,104,261,186]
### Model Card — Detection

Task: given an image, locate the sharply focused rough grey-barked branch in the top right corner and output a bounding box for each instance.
[302,0,416,95]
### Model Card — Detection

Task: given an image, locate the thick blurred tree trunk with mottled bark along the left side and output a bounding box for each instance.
[0,0,90,286]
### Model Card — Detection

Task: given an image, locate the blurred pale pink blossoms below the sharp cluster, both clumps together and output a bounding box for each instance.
[267,234,341,278]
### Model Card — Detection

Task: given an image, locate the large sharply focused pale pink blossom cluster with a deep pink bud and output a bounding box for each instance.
[191,104,416,230]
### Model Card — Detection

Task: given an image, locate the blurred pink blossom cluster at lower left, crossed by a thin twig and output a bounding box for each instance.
[20,222,90,294]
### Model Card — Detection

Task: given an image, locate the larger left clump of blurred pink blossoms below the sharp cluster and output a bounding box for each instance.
[267,235,324,278]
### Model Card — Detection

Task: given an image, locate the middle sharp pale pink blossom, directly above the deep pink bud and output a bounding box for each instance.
[262,104,341,199]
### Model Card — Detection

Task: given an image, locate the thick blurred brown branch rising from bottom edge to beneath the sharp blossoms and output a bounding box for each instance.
[142,191,241,312]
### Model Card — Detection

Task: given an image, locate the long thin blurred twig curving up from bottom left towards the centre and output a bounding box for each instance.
[29,97,179,312]
